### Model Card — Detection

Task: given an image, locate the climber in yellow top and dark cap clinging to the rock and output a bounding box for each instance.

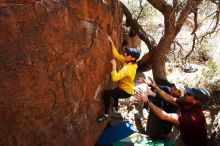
[97,36,140,122]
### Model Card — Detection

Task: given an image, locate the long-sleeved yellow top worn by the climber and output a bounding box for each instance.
[111,48,138,94]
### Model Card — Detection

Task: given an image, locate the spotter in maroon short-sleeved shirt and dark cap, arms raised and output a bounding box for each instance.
[135,78,210,146]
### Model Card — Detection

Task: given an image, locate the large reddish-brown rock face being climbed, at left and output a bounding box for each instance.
[0,0,122,146]
